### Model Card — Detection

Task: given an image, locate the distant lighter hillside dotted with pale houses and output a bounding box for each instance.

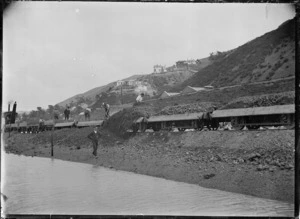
[58,58,212,108]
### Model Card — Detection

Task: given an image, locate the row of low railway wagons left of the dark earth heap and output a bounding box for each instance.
[5,120,103,133]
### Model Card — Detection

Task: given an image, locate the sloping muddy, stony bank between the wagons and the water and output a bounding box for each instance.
[3,128,295,203]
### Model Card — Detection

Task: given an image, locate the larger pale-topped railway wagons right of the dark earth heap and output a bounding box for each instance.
[133,104,295,132]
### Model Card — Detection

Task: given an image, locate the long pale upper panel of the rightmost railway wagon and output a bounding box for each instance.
[213,104,295,118]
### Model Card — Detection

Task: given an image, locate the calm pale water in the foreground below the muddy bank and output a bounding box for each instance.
[1,154,294,216]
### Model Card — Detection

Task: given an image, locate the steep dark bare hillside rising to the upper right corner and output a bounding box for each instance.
[170,19,295,91]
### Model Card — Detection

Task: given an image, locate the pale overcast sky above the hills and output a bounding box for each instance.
[2,1,295,111]
